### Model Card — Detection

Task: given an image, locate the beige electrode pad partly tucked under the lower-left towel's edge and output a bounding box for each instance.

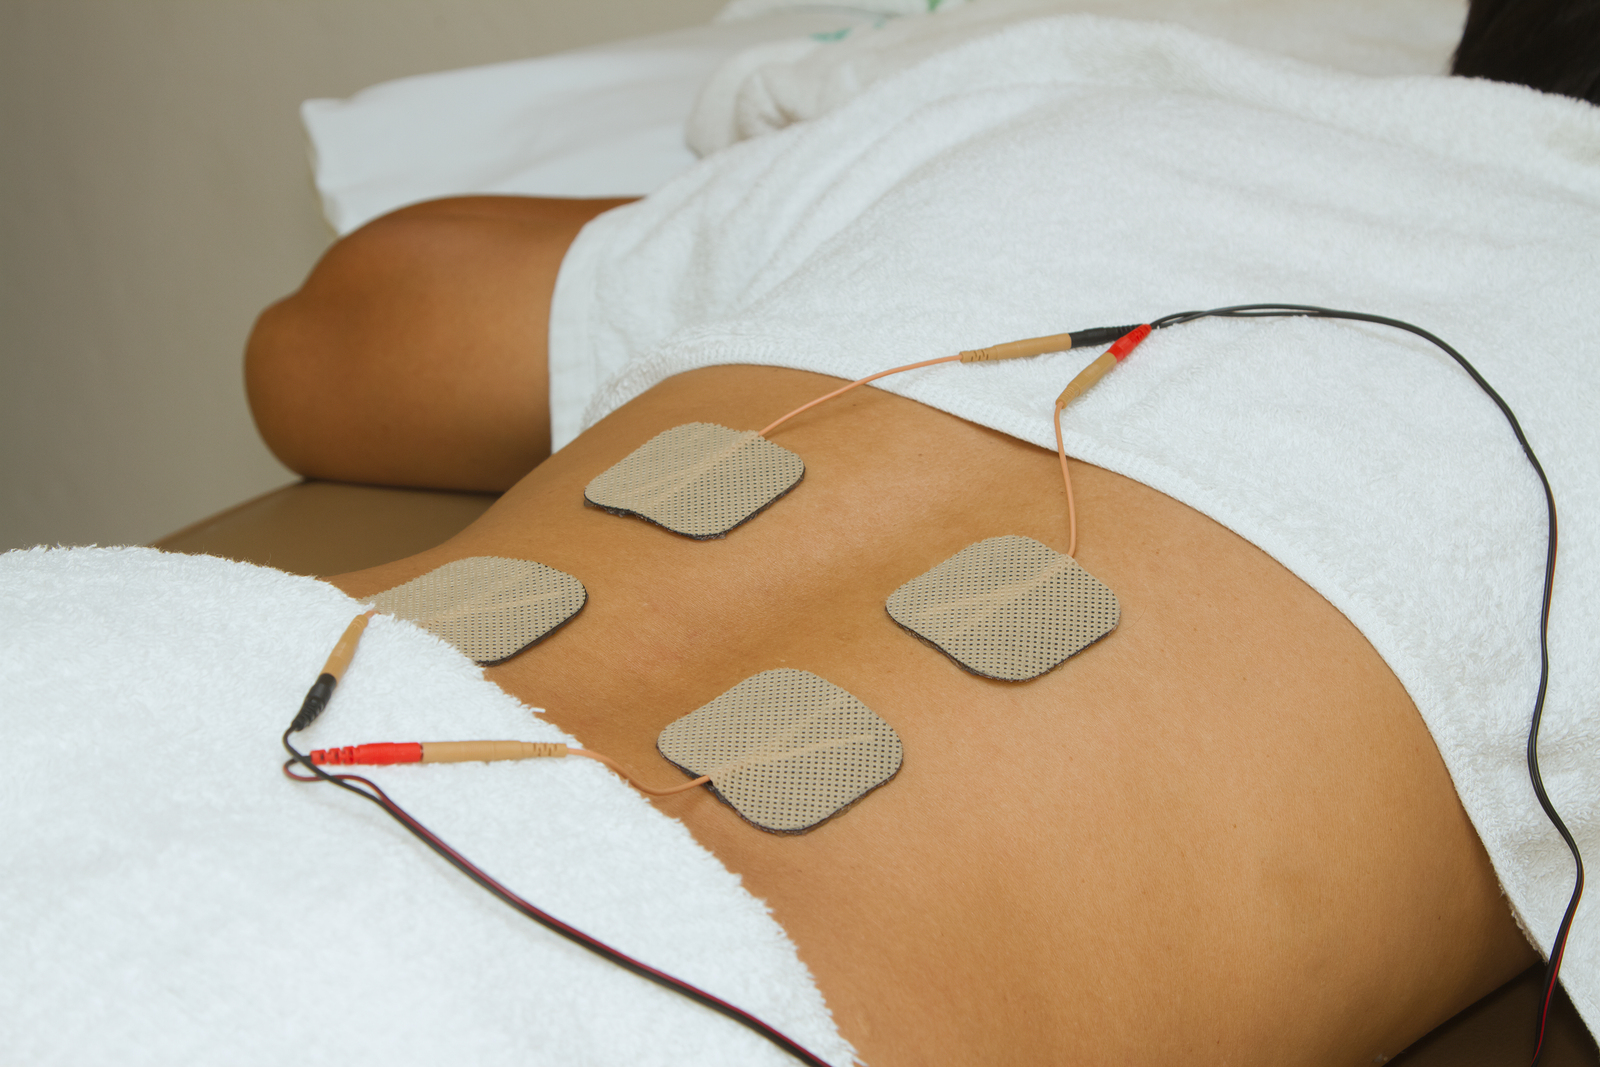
[366,555,589,664]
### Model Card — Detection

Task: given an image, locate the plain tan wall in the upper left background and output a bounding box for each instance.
[0,0,722,550]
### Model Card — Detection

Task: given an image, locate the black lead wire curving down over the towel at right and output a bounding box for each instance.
[1150,304,1584,1067]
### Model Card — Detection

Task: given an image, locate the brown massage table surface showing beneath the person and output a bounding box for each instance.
[154,480,1600,1067]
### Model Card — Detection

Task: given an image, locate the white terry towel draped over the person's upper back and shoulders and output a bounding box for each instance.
[552,5,1600,1027]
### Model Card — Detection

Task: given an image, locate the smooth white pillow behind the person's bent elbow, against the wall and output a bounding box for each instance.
[301,6,872,234]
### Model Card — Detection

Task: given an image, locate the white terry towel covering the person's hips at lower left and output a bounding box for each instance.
[0,549,851,1067]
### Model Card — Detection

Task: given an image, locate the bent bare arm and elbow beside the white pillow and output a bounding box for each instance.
[245,197,627,491]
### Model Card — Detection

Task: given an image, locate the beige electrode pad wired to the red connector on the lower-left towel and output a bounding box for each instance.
[656,667,901,833]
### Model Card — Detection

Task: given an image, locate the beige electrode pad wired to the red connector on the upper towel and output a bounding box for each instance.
[886,534,1122,681]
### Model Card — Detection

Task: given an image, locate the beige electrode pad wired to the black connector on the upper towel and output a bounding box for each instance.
[584,422,805,539]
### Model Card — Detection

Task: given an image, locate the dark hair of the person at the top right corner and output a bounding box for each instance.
[1450,0,1600,104]
